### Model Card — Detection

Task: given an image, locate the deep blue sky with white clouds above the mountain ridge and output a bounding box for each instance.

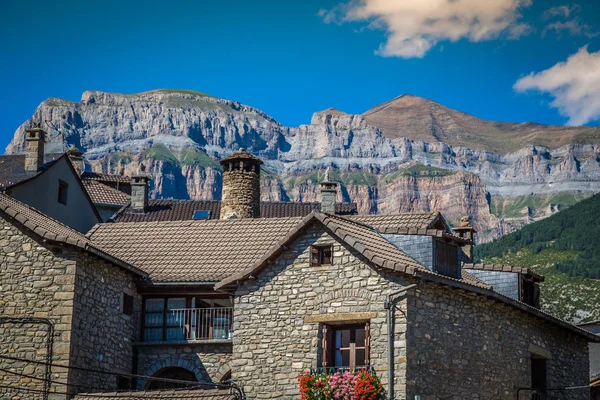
[0,0,600,149]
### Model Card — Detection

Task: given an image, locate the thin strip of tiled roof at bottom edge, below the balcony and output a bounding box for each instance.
[75,389,238,400]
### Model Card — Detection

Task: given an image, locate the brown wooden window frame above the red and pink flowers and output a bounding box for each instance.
[321,321,371,369]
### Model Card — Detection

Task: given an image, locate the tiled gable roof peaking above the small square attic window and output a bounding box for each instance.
[215,212,425,288]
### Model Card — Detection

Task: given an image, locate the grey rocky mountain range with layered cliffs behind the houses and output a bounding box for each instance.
[6,90,600,242]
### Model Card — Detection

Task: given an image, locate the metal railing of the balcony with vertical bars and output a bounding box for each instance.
[168,307,233,340]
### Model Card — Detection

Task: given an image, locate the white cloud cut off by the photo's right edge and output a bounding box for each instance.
[513,46,600,125]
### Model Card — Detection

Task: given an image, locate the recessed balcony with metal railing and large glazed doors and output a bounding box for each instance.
[144,307,233,343]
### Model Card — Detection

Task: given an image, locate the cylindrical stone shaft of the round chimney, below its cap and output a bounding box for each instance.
[221,167,260,219]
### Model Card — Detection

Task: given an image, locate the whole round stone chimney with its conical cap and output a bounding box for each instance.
[220,149,263,219]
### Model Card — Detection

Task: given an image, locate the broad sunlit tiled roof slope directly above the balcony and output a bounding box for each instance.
[88,218,301,282]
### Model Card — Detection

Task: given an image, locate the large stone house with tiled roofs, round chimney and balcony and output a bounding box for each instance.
[0,148,600,399]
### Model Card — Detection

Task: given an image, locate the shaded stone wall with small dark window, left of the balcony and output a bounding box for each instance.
[69,254,141,391]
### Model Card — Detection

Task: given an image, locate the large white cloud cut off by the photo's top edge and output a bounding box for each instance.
[318,0,531,58]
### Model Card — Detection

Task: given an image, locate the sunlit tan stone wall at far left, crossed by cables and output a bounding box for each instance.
[0,216,77,399]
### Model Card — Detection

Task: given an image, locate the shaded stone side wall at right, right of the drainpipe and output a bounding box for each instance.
[406,283,589,400]
